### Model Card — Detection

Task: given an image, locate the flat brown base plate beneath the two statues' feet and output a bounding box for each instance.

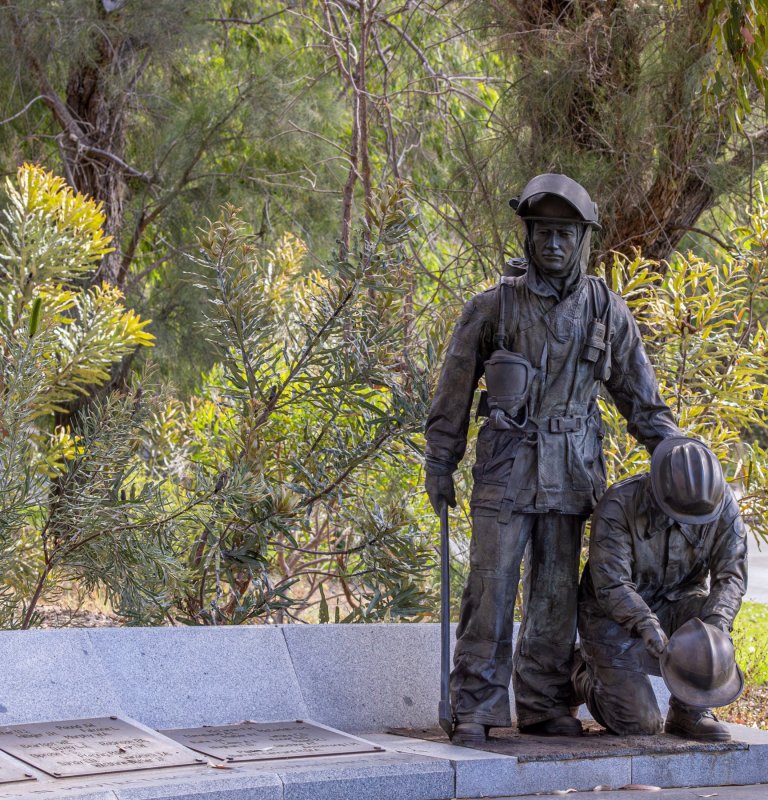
[387,722,748,763]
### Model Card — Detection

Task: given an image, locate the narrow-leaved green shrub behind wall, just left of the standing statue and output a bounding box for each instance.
[146,191,432,624]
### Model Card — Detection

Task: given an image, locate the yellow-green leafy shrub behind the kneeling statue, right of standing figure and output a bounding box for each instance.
[601,201,768,539]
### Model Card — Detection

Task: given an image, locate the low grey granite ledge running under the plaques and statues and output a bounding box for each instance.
[0,725,768,800]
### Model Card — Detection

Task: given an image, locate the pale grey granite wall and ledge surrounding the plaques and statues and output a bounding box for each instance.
[0,624,768,800]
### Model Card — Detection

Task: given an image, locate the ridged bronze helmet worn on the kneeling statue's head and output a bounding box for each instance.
[651,436,725,525]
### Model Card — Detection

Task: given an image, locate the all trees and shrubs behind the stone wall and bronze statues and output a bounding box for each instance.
[0,0,768,688]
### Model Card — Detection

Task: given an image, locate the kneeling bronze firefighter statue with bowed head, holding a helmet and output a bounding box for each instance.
[574,437,747,742]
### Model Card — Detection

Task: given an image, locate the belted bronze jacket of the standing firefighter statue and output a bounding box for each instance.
[426,262,680,521]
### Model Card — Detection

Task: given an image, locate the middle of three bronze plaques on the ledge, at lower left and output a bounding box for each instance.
[0,717,203,778]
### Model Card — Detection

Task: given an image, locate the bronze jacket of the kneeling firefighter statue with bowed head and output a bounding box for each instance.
[579,474,747,657]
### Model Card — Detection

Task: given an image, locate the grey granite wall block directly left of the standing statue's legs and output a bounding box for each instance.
[283,624,462,732]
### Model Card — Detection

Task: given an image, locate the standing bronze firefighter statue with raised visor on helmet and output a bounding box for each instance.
[426,174,679,744]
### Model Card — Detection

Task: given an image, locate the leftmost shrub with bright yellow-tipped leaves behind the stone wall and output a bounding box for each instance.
[0,165,158,626]
